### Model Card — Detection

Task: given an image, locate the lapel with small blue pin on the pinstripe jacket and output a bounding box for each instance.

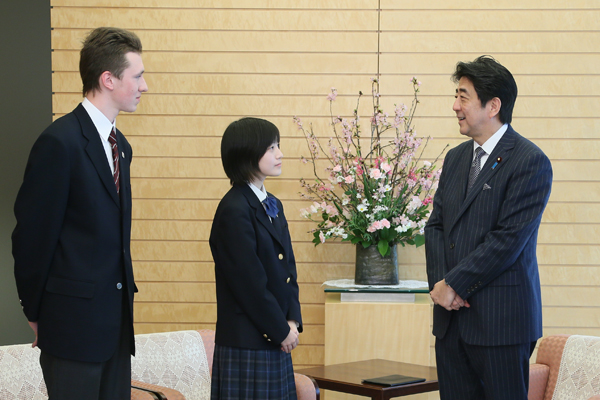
[450,125,516,229]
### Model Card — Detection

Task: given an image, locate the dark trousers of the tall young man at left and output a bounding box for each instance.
[40,294,131,400]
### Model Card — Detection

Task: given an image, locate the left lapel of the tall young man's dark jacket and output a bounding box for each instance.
[73,104,124,207]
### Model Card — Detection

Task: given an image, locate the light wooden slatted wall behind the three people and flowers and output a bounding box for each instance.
[51,0,600,367]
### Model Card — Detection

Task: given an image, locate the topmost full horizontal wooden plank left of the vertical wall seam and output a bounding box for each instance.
[52,7,377,32]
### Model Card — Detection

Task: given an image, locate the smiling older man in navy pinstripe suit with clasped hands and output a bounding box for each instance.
[425,56,552,400]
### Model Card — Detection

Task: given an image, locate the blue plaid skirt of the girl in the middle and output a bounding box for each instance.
[210,344,297,400]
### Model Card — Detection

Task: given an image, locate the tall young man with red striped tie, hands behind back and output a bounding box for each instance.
[12,28,148,400]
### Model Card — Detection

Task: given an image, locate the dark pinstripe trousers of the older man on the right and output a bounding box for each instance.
[435,315,536,400]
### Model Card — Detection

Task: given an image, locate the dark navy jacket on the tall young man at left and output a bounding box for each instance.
[12,104,135,362]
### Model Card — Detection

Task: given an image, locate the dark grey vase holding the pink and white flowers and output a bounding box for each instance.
[354,244,398,285]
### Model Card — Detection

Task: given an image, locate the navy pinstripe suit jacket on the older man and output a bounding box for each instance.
[425,126,552,346]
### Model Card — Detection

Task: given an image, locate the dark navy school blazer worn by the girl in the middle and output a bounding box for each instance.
[210,184,302,350]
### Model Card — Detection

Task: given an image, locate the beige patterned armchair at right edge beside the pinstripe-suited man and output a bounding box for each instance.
[528,335,600,400]
